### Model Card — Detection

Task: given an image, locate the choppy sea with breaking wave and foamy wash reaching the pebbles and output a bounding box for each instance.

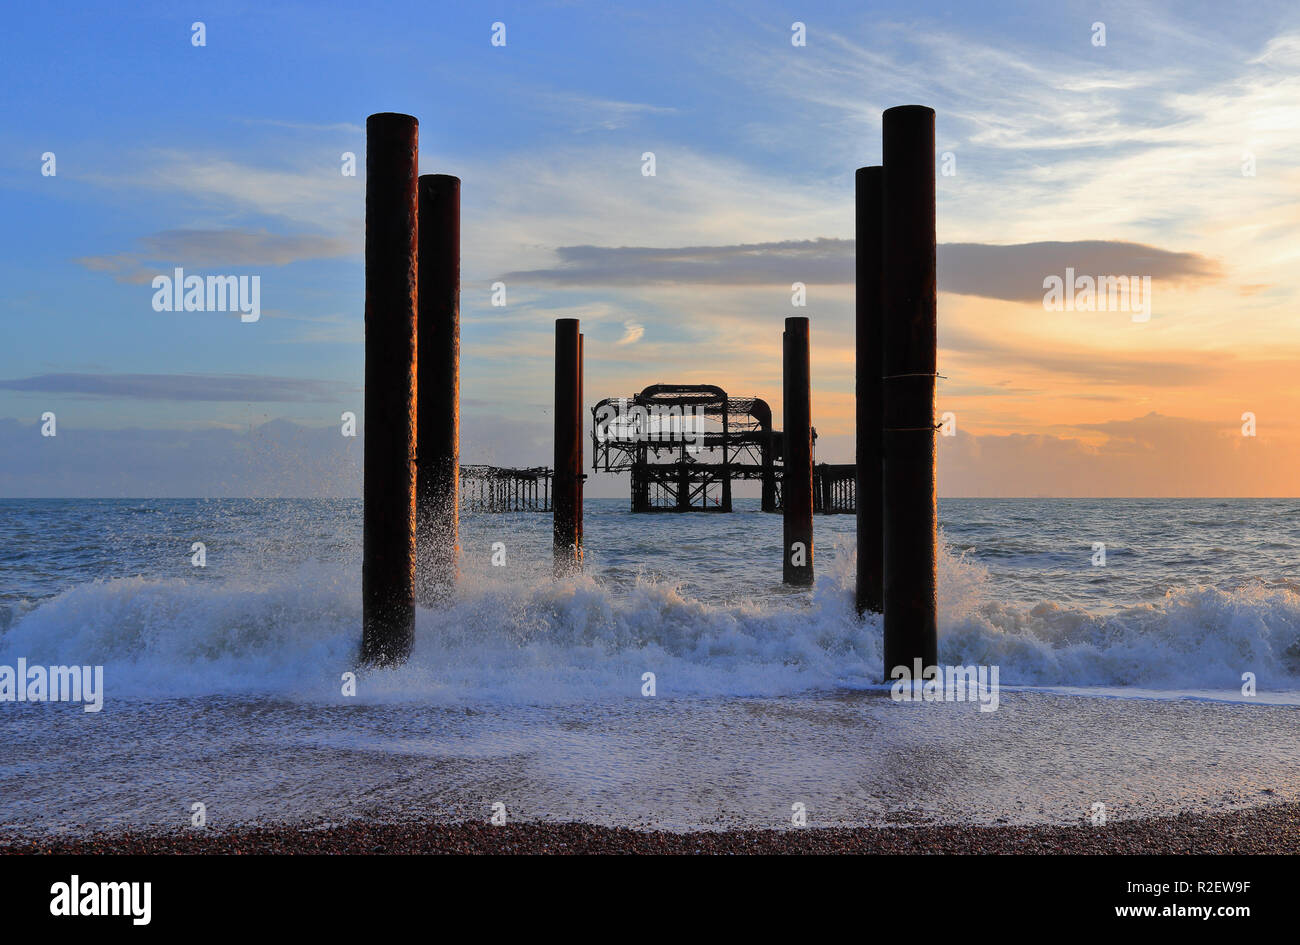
[0,499,1300,833]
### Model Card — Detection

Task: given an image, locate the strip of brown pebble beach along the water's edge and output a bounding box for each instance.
[0,803,1300,855]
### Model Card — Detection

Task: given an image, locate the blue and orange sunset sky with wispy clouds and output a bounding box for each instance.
[0,0,1300,497]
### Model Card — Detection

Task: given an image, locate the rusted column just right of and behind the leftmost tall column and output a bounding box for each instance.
[416,174,460,606]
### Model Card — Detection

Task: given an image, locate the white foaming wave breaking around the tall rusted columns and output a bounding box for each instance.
[0,535,1300,705]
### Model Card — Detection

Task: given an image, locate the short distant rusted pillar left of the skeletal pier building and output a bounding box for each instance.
[551,318,584,577]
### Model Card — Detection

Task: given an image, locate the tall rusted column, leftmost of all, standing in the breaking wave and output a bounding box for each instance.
[361,113,420,664]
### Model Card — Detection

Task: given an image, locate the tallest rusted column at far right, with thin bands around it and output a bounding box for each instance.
[881,105,939,681]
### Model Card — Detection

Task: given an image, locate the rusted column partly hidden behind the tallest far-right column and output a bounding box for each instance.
[854,166,884,614]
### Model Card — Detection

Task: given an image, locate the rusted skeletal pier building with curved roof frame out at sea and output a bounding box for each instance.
[592,383,816,512]
